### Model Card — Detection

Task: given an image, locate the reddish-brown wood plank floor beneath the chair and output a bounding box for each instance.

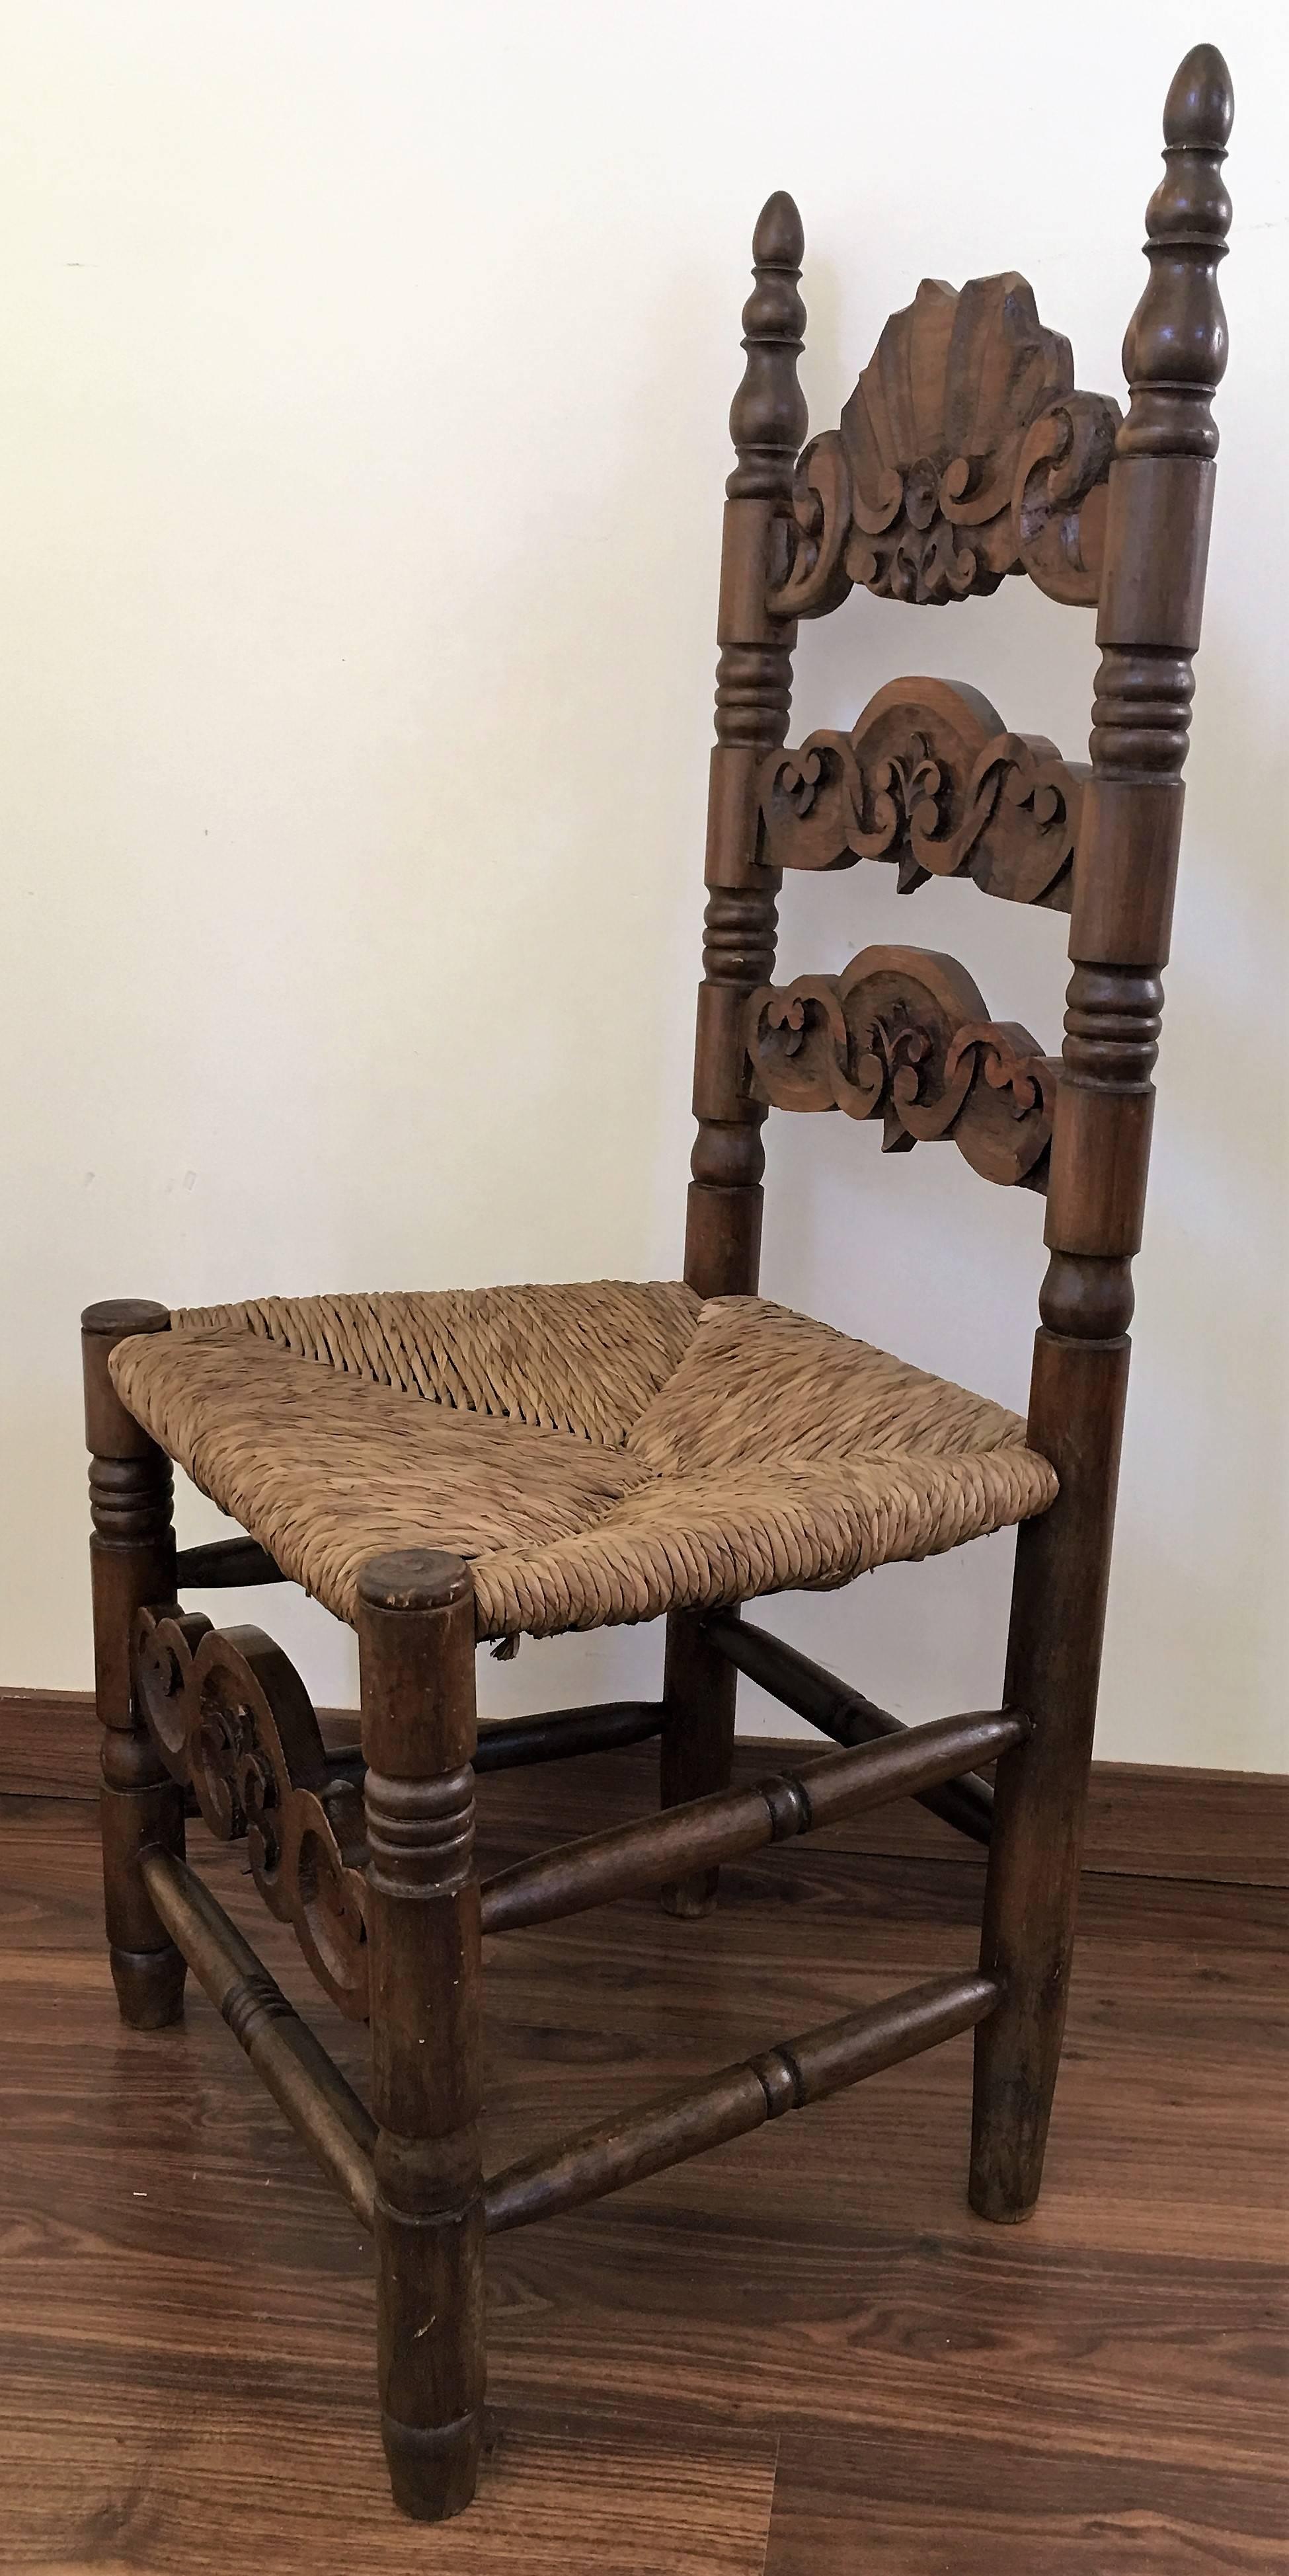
[0,1747,1289,2576]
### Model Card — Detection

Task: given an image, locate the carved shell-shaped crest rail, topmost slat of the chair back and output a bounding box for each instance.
[768,270,1122,619]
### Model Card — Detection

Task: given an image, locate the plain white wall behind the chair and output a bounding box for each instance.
[0,0,1289,1767]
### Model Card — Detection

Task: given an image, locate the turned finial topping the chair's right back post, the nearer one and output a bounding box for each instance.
[1116,44,1235,456]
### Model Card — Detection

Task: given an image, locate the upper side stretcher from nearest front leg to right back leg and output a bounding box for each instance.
[482,1710,1029,1932]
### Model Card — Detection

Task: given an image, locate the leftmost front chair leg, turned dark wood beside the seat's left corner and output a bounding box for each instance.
[80,1301,188,2030]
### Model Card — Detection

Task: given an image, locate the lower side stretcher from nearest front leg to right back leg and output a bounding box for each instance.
[485,1976,1000,2236]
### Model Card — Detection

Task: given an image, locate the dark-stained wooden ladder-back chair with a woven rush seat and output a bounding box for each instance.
[85,46,1232,2519]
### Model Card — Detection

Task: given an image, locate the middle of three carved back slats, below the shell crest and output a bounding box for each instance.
[758,680,1091,912]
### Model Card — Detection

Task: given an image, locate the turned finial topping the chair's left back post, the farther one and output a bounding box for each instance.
[724,188,810,500]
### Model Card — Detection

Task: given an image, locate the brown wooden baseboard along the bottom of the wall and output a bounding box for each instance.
[0,1690,1289,1888]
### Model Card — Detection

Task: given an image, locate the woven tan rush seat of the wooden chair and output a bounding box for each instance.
[111,1280,1057,1638]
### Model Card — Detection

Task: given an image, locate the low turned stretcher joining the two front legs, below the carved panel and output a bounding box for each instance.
[142,1852,376,2231]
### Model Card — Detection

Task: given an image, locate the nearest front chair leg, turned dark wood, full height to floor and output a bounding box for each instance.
[358,1548,485,2522]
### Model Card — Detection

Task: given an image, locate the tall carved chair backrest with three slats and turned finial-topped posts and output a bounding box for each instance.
[685,46,1232,1332]
